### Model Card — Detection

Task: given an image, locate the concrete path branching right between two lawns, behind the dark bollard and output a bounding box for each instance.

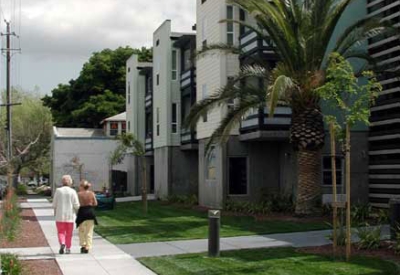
[118,226,390,258]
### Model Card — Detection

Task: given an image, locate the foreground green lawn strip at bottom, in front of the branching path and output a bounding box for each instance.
[139,248,400,275]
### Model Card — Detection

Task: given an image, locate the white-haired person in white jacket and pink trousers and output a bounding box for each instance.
[53,175,79,254]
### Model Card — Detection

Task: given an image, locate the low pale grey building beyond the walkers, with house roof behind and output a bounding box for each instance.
[50,113,130,193]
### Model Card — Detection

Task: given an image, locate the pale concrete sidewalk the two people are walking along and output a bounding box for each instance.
[27,199,155,275]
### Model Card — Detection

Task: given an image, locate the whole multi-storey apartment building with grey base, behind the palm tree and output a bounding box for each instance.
[123,0,379,207]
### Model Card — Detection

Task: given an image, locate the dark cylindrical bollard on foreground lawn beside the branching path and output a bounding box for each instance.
[208,210,221,257]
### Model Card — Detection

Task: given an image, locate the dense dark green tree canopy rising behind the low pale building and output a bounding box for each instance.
[43,47,152,128]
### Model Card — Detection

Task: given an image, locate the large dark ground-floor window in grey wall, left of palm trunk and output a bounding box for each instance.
[229,157,247,195]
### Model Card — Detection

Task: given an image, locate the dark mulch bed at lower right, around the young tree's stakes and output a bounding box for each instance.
[298,244,400,262]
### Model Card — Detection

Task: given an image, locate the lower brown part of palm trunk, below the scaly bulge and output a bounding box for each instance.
[296,149,321,215]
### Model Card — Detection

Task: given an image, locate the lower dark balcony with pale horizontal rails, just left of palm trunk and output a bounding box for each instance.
[240,107,292,141]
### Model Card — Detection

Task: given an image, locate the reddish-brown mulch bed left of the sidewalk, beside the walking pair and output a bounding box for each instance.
[0,209,49,248]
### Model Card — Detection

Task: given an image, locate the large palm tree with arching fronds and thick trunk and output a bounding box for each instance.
[186,0,386,215]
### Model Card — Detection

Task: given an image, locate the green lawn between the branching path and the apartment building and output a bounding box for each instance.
[96,202,328,244]
